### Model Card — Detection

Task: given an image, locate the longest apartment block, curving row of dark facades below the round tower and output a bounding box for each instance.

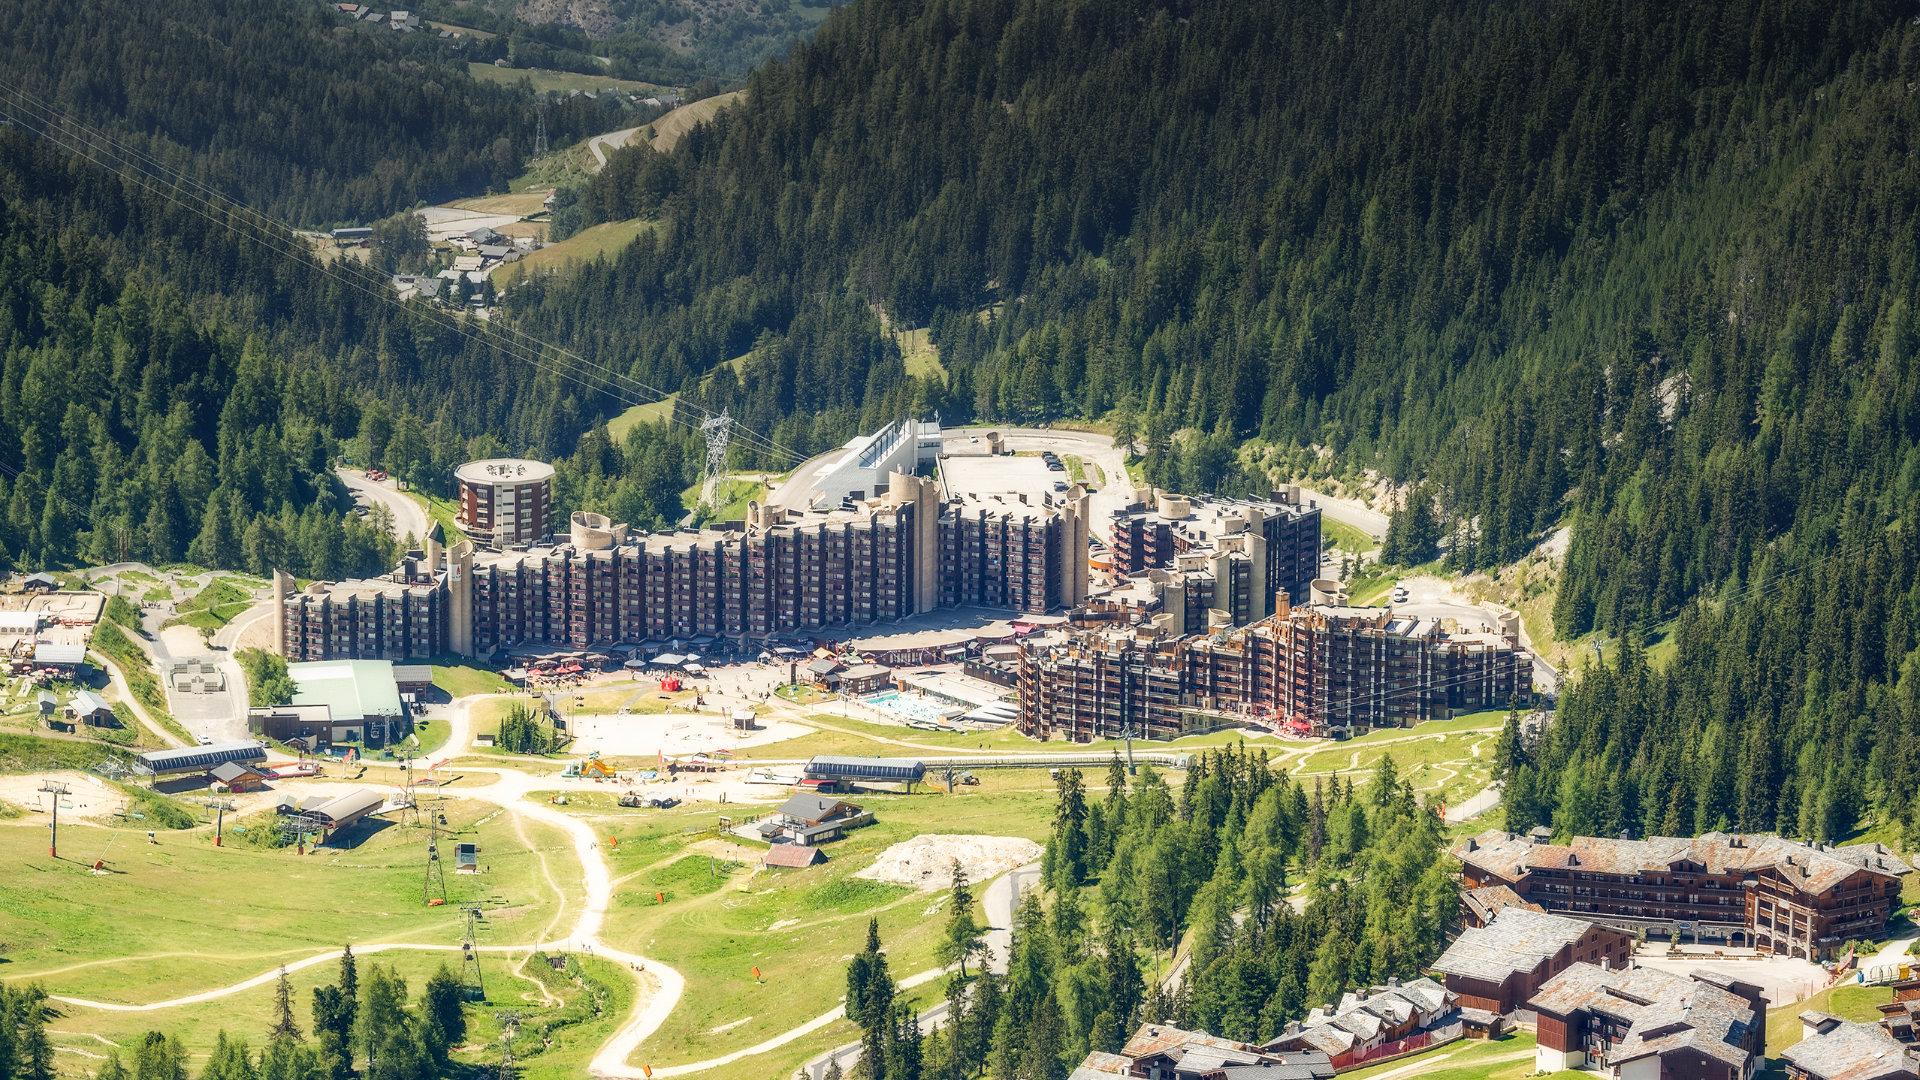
[276,473,1089,659]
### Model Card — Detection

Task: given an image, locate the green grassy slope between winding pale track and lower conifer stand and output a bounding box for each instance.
[568,771,1052,1080]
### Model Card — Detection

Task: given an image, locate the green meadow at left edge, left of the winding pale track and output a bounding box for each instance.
[0,799,578,1006]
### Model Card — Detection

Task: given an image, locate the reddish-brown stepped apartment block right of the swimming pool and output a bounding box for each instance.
[1020,594,1532,742]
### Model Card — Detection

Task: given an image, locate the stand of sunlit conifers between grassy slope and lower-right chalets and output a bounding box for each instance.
[835,746,1459,1080]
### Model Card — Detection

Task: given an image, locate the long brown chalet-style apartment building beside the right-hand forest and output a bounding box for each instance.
[1453,830,1910,959]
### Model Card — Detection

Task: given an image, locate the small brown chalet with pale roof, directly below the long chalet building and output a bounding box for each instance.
[1432,907,1634,1017]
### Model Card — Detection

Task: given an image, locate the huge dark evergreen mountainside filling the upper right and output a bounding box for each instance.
[513,0,1920,836]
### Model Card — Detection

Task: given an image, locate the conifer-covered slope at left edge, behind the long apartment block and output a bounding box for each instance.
[0,119,625,578]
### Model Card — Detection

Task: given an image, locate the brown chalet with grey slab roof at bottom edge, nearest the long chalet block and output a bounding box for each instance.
[1526,963,1766,1080]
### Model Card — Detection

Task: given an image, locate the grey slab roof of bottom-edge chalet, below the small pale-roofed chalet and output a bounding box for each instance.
[1528,963,1761,1072]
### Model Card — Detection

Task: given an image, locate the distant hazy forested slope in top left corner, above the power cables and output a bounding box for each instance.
[0,0,620,225]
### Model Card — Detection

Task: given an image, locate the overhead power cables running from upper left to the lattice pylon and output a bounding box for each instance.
[0,83,804,463]
